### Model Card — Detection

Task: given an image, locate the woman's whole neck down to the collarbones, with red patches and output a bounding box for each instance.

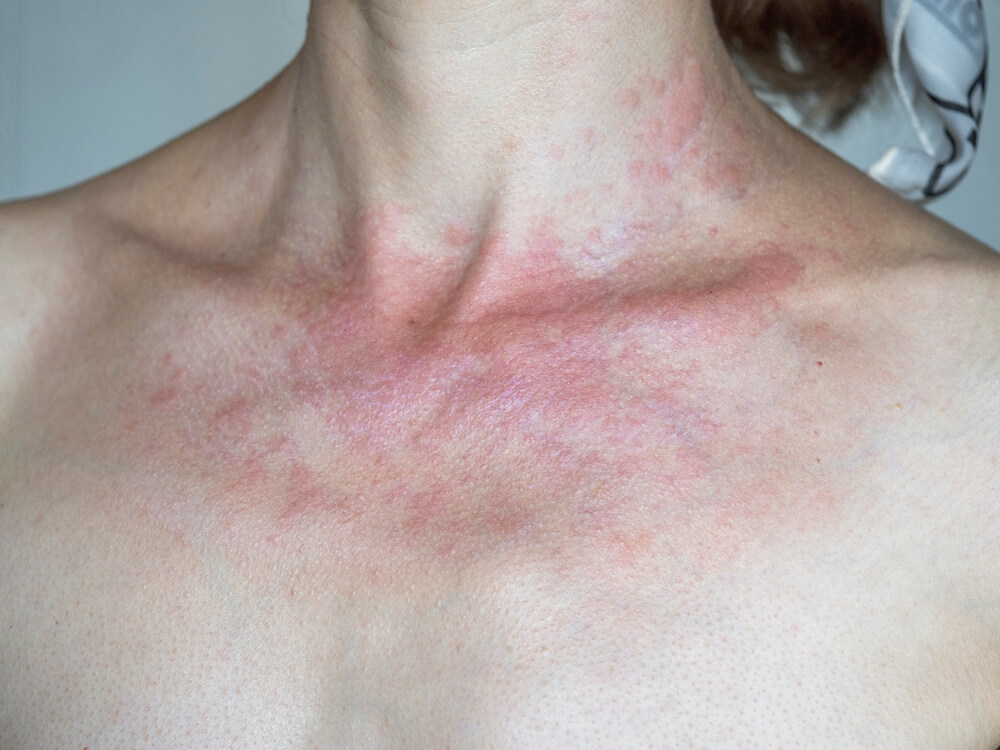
[123,0,796,326]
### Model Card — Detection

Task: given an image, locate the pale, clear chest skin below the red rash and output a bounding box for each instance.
[0,446,1000,750]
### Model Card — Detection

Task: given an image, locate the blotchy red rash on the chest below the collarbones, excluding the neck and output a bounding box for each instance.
[133,229,803,566]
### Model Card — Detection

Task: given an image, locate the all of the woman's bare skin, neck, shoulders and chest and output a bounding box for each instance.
[0,0,1000,750]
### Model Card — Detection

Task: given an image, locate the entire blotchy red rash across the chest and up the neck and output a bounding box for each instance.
[125,58,804,568]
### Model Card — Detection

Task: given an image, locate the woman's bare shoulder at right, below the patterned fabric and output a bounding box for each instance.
[818,186,1000,406]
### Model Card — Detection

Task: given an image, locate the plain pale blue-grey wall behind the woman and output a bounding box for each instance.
[0,0,1000,253]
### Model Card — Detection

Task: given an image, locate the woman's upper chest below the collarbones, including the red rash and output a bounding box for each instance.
[0,244,998,748]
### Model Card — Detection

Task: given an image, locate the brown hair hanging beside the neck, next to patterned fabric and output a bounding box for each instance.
[712,0,887,127]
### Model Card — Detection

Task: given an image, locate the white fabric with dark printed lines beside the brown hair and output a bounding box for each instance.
[868,0,987,201]
